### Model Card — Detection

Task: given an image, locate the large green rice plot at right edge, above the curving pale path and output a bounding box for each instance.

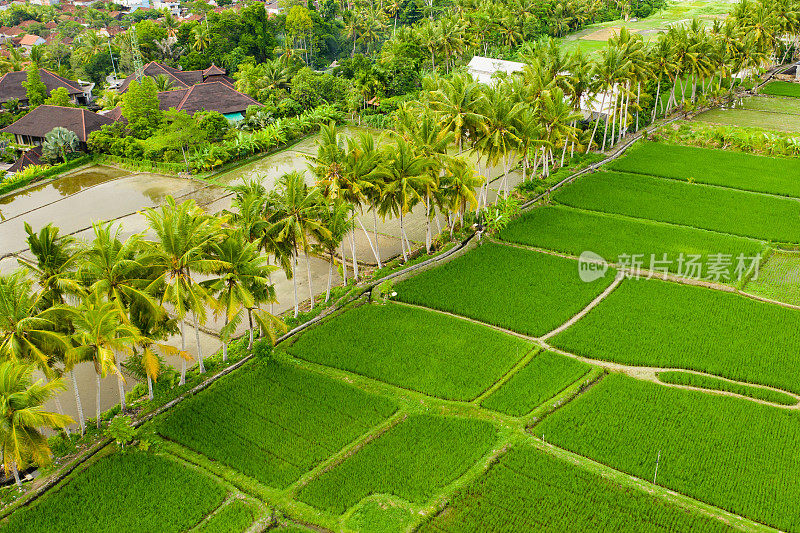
[552,280,800,392]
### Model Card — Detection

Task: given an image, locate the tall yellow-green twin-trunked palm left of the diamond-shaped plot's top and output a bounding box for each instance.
[145,196,225,385]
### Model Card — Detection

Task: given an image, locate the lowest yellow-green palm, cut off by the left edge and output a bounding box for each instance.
[0,361,74,490]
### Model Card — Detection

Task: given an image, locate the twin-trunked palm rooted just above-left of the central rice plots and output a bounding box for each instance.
[270,171,330,317]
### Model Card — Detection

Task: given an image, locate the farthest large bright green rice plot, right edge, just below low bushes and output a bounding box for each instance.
[609,141,800,197]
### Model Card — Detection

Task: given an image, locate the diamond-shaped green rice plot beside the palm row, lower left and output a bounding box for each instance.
[158,360,396,488]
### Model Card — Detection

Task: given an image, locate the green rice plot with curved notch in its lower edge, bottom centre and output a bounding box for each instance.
[298,415,497,514]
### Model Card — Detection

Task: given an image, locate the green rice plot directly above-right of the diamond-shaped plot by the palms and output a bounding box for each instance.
[287,303,532,400]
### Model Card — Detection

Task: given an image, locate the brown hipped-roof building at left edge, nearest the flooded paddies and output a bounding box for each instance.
[0,105,114,150]
